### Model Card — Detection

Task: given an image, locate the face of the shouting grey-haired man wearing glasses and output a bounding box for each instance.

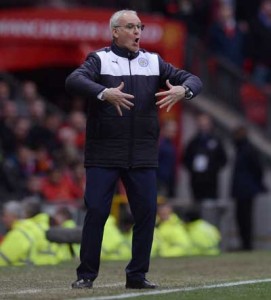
[112,13,142,52]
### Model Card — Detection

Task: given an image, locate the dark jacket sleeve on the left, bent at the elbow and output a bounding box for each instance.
[65,53,105,98]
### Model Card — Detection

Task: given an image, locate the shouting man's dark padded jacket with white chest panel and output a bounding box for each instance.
[66,43,202,168]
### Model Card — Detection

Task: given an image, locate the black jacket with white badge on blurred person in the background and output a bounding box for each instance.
[184,133,227,201]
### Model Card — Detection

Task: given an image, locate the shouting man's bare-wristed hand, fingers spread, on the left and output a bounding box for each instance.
[103,82,134,116]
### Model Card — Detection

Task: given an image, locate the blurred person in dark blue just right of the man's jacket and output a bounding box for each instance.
[157,120,178,198]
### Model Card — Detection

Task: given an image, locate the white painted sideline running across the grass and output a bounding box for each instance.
[76,278,271,300]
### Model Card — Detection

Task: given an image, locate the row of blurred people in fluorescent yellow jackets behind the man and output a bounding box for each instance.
[0,198,221,267]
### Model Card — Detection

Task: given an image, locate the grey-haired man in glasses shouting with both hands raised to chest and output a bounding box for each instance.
[66,10,201,289]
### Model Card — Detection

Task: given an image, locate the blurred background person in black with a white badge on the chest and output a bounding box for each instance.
[183,113,227,224]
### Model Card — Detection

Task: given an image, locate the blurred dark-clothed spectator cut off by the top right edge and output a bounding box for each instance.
[250,0,271,92]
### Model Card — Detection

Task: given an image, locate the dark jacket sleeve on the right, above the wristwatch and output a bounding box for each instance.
[158,56,202,97]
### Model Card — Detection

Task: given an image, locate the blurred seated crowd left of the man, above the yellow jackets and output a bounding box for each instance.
[0,79,85,205]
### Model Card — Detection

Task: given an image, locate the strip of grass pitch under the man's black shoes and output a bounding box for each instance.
[0,251,271,300]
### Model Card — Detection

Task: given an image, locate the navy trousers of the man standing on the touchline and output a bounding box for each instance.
[77,167,157,280]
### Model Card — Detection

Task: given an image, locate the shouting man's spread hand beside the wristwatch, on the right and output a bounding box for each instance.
[155,80,185,112]
